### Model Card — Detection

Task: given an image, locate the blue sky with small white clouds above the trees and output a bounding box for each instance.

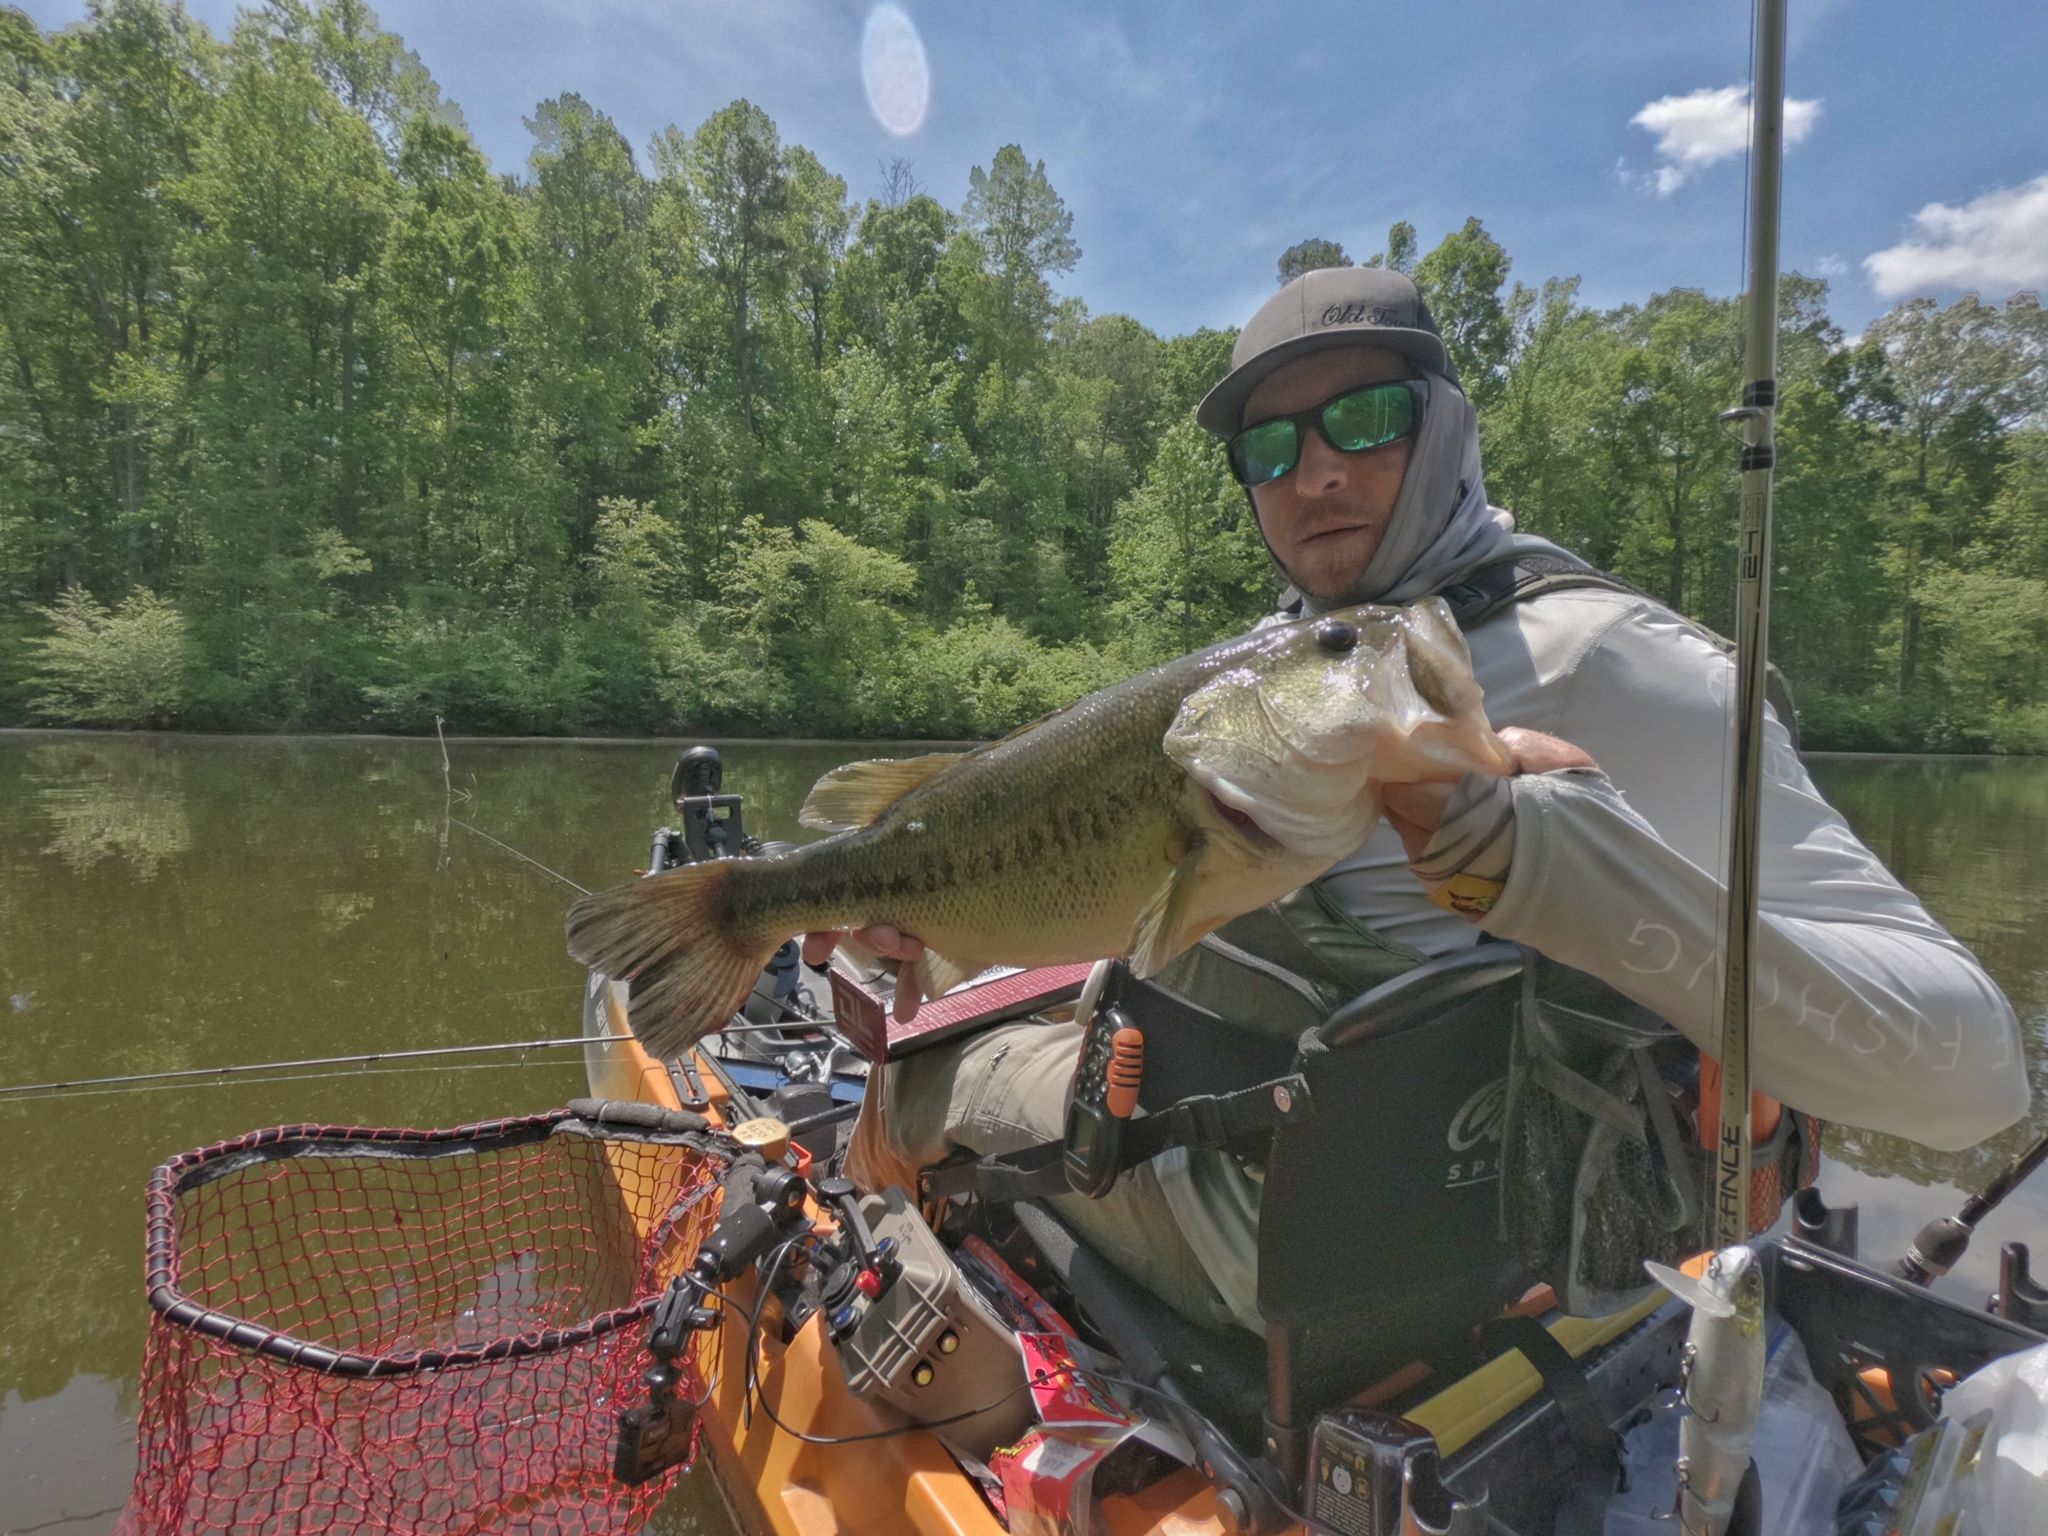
[27,0,2048,334]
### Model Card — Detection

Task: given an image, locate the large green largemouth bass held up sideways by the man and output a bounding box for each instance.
[567,598,1513,1057]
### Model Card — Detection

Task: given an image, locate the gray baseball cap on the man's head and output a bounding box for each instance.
[1194,266,1458,438]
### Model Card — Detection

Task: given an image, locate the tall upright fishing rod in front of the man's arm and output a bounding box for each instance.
[1710,0,1786,1247]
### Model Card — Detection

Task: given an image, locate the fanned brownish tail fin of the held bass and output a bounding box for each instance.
[567,860,782,1061]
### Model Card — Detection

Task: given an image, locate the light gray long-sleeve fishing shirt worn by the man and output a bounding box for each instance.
[1159,590,2028,1325]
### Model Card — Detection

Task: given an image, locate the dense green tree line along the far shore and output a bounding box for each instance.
[0,0,2048,754]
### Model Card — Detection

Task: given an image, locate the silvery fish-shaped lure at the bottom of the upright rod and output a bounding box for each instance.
[1642,1245,1765,1536]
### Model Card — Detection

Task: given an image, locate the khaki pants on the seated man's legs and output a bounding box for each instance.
[885,1022,1237,1331]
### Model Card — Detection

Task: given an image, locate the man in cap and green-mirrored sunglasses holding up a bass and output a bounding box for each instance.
[805,268,2028,1329]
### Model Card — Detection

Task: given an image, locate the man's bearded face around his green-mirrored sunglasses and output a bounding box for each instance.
[1245,346,1413,602]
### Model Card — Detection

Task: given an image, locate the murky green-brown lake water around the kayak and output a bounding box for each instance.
[0,733,2048,1534]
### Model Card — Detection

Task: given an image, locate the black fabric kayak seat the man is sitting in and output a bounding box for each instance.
[1018,942,1534,1454]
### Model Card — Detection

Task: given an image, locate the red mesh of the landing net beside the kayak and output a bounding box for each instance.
[121,1112,719,1536]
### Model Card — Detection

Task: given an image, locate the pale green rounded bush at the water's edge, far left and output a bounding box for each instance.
[29,588,184,729]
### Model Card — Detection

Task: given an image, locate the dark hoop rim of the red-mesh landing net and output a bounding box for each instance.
[143,1110,719,1380]
